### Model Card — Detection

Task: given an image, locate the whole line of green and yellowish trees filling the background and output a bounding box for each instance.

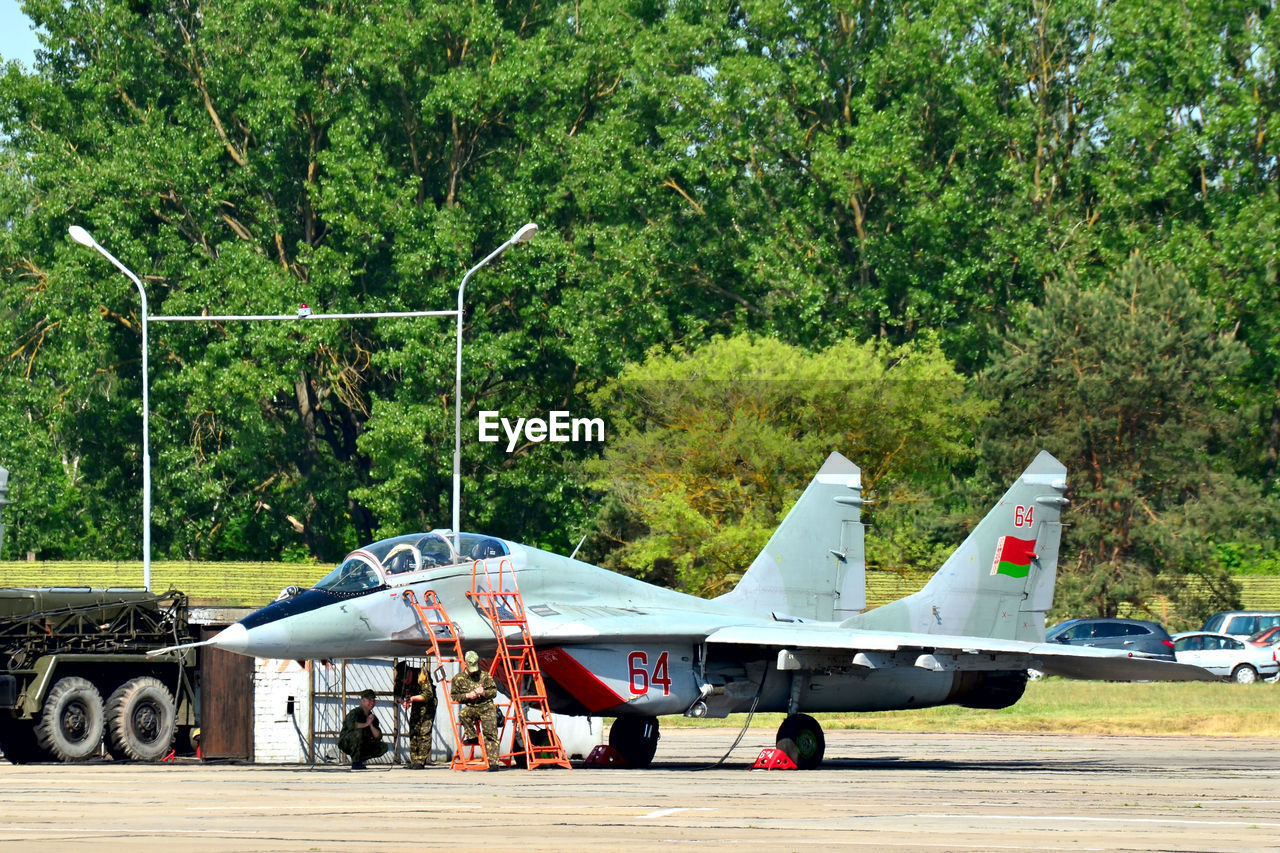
[0,0,1280,612]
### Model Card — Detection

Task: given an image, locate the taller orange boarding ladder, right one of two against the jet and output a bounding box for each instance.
[467,558,570,770]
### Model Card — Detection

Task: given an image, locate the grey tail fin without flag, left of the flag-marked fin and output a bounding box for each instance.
[717,453,867,621]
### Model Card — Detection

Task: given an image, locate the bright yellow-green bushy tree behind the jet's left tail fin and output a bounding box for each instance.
[588,336,983,593]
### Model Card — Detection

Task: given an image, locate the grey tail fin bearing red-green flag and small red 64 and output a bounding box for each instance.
[845,451,1068,642]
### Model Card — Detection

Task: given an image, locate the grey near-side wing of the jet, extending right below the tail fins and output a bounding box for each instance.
[707,624,1221,681]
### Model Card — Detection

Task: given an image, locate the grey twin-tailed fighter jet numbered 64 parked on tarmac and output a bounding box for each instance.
[186,452,1213,768]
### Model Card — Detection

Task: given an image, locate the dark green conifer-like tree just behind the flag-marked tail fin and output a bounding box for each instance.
[979,256,1274,616]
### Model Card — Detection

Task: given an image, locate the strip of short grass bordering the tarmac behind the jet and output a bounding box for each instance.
[663,679,1280,738]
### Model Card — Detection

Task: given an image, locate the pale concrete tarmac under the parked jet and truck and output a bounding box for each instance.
[0,729,1280,853]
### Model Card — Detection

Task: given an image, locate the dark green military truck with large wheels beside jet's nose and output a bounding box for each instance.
[0,587,197,763]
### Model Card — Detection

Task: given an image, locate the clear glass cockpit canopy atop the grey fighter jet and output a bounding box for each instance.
[315,532,511,594]
